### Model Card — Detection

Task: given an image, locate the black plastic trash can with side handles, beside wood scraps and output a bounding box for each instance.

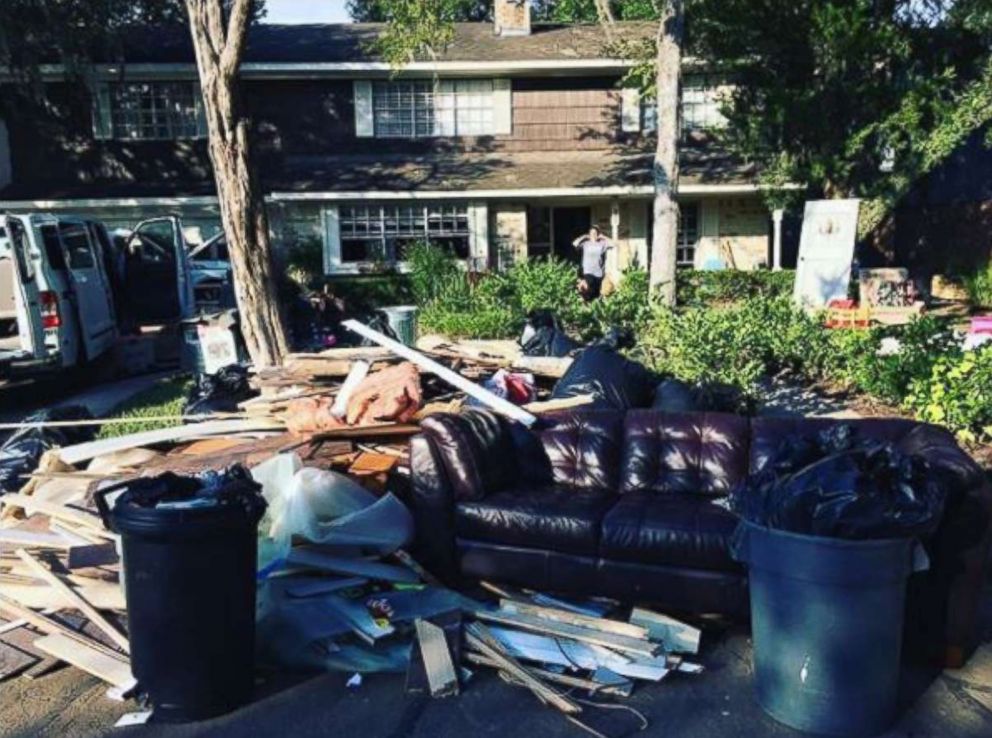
[97,472,265,722]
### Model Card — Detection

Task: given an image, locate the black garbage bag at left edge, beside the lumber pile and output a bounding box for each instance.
[0,405,98,493]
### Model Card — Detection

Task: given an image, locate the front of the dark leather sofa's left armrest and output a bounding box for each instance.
[410,434,458,584]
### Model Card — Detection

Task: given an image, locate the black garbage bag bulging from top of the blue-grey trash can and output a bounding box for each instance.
[731,425,948,540]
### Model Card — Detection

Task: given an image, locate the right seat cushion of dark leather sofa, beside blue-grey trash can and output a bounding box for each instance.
[599,491,741,571]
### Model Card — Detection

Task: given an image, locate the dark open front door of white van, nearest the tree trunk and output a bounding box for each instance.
[125,215,194,325]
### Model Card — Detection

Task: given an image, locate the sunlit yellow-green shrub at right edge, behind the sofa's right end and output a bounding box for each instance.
[906,344,992,442]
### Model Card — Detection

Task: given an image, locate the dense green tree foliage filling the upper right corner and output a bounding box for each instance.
[689,0,992,202]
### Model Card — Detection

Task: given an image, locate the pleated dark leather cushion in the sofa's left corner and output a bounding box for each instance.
[420,410,515,500]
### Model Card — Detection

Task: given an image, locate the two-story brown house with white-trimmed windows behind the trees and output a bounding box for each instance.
[0,0,774,274]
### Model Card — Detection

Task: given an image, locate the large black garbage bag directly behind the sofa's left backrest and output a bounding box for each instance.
[551,346,657,410]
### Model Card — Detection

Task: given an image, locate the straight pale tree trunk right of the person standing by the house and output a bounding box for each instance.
[650,0,683,305]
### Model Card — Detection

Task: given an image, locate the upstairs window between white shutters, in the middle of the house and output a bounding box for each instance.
[372,79,496,138]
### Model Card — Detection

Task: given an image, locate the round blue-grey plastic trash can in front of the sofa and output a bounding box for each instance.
[734,521,916,736]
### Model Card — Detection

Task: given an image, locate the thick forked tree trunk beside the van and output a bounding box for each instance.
[186,0,287,368]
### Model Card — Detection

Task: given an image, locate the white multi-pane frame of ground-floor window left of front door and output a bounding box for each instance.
[323,200,489,274]
